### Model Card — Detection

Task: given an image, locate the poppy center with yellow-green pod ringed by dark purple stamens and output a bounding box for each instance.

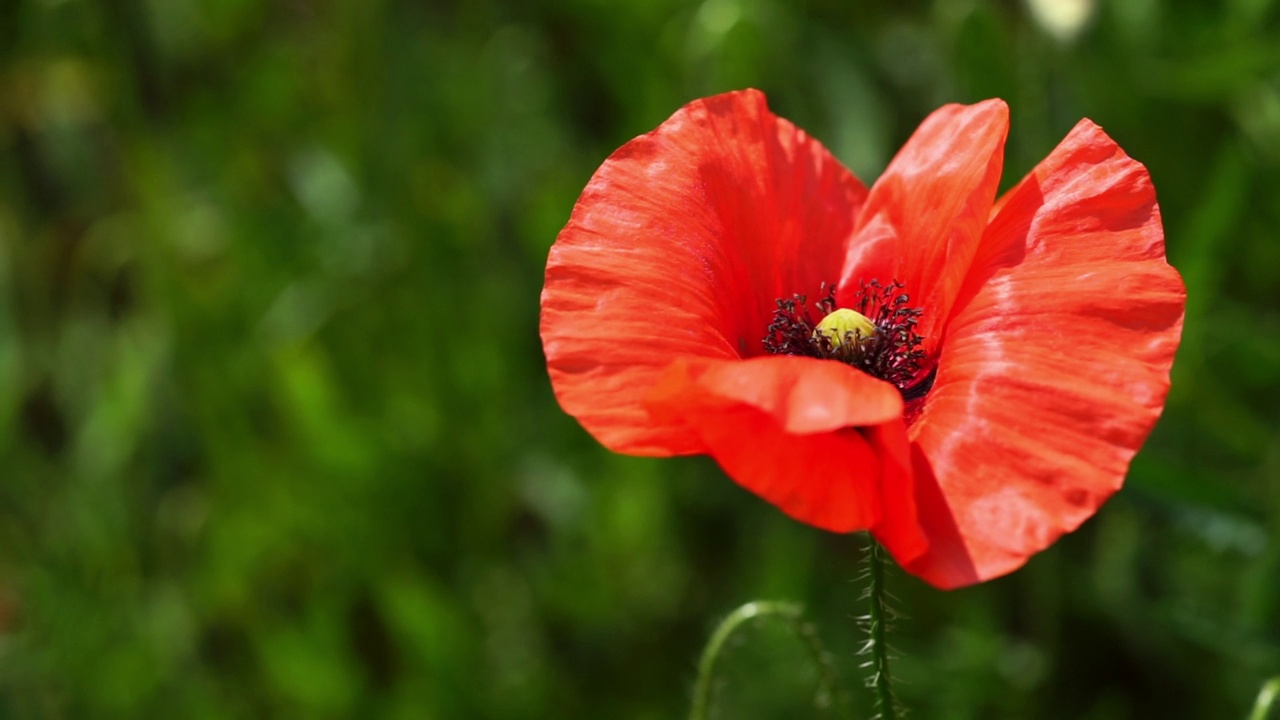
[764,281,937,401]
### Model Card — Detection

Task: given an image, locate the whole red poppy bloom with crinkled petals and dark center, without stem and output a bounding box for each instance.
[541,91,1185,588]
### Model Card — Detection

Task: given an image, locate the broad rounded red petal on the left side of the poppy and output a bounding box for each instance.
[540,91,867,455]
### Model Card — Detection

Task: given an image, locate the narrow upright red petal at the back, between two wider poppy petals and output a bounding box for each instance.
[838,99,1009,355]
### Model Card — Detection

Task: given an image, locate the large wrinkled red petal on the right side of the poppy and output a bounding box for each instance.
[908,120,1185,588]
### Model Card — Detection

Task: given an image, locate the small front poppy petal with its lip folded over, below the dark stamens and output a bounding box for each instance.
[648,356,924,530]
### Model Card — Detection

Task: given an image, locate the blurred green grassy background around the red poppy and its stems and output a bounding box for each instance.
[0,0,1280,720]
